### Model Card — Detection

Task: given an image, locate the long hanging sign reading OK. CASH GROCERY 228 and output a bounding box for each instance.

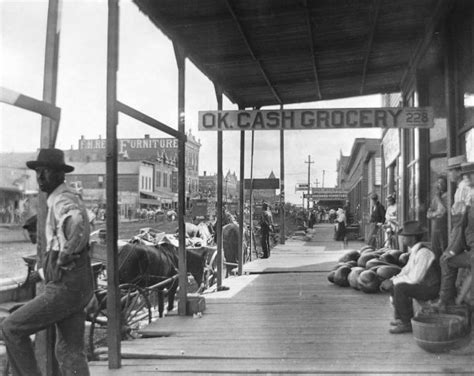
[199,107,434,131]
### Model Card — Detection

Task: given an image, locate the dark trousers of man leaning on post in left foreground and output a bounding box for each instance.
[2,251,93,376]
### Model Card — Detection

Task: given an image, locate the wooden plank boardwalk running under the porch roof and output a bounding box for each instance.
[90,226,474,375]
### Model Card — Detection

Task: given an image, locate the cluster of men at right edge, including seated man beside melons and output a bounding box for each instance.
[381,156,474,334]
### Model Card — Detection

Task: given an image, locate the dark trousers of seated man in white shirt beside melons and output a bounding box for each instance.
[392,283,439,323]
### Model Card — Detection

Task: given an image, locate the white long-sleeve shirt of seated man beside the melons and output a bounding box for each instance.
[392,242,435,285]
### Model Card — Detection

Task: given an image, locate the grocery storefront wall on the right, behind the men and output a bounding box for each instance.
[382,1,474,235]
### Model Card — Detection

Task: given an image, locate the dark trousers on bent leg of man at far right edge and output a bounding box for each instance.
[439,252,471,304]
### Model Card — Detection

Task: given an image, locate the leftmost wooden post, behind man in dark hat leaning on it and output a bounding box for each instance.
[35,0,62,376]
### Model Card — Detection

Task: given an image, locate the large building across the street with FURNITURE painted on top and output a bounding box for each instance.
[65,132,201,217]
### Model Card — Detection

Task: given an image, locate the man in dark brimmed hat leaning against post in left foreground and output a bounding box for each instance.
[2,149,93,376]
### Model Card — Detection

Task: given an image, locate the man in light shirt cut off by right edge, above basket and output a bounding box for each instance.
[434,162,474,310]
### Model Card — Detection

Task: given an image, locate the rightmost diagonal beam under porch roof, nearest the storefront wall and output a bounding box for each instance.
[400,0,455,92]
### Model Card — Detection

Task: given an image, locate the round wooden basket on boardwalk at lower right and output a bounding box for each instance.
[411,314,470,353]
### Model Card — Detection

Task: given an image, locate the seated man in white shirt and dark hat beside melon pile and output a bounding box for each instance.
[380,221,440,334]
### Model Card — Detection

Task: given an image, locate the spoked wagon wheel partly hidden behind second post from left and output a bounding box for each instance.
[89,284,152,359]
